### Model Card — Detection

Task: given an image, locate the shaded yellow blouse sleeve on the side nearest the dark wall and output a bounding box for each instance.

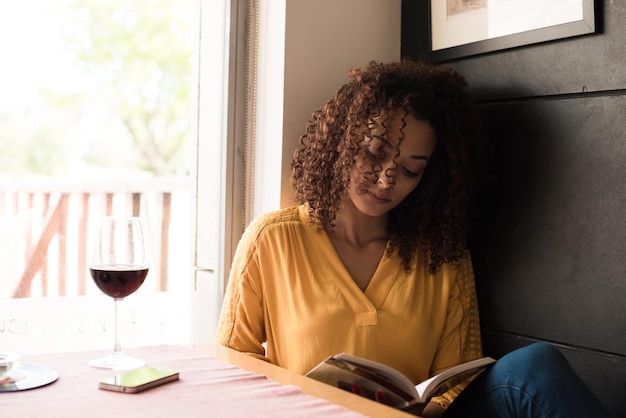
[431,253,483,409]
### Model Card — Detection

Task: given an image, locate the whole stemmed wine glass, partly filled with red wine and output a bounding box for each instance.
[89,217,149,370]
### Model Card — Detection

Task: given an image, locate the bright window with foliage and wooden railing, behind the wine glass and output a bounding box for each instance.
[0,0,198,353]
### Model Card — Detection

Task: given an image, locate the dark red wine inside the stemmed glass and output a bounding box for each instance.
[89,265,148,299]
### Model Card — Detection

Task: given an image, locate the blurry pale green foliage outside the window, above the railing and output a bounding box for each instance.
[0,0,197,178]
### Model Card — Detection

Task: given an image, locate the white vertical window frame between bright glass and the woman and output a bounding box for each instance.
[190,0,250,344]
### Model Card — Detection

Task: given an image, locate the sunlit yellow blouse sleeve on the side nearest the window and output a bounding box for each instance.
[215,217,268,361]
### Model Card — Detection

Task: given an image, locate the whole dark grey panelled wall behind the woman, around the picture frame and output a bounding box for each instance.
[402,0,626,417]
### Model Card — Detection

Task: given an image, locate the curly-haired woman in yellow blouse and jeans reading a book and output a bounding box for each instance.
[216,61,601,416]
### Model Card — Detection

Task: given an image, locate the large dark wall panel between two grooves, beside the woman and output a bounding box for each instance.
[473,96,626,355]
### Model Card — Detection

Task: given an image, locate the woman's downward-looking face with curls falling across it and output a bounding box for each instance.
[348,115,436,216]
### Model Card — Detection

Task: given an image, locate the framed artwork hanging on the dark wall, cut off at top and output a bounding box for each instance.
[428,0,599,61]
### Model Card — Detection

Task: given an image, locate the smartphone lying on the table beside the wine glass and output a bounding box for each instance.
[98,367,179,393]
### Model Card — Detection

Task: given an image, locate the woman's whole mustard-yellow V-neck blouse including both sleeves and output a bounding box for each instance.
[216,205,482,408]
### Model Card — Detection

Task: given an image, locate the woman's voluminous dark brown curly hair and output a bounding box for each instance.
[291,60,485,274]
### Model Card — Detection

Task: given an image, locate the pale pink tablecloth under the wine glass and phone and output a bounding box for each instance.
[0,346,362,418]
